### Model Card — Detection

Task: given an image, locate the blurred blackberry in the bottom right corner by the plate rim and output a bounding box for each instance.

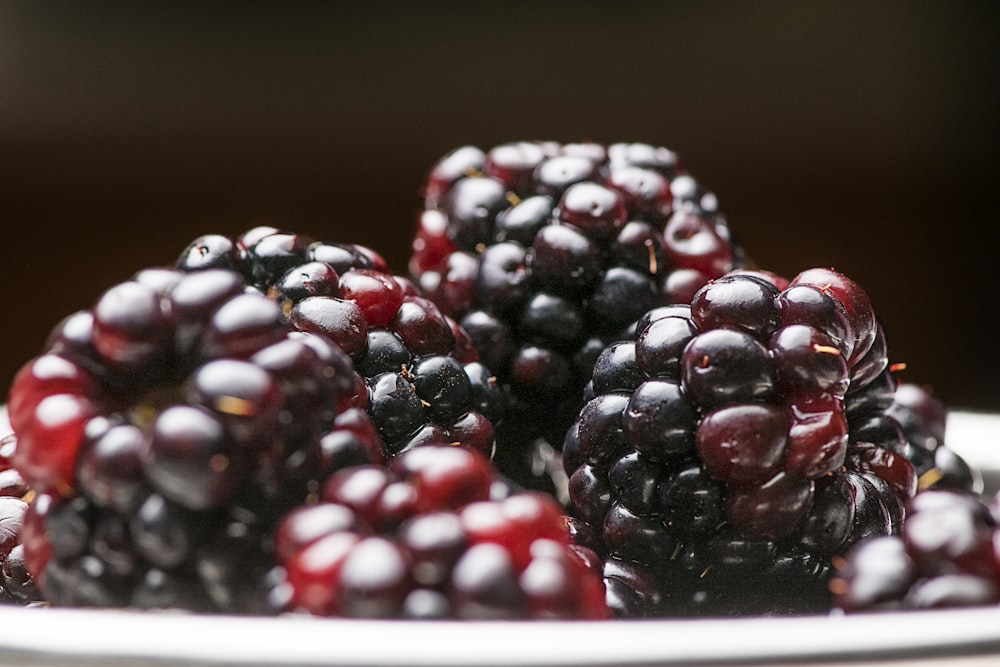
[830,489,1000,612]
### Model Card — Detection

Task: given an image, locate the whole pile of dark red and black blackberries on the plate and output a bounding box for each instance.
[0,142,1000,619]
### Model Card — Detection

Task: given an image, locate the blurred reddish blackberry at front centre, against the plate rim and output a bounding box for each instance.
[276,445,608,620]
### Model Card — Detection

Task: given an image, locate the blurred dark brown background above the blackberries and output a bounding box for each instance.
[0,0,1000,411]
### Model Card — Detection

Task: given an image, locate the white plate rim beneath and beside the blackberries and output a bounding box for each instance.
[0,412,1000,667]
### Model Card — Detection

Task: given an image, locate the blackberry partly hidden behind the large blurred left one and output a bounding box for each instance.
[177,227,504,464]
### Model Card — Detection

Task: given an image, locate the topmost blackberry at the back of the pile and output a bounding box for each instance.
[410,142,743,483]
